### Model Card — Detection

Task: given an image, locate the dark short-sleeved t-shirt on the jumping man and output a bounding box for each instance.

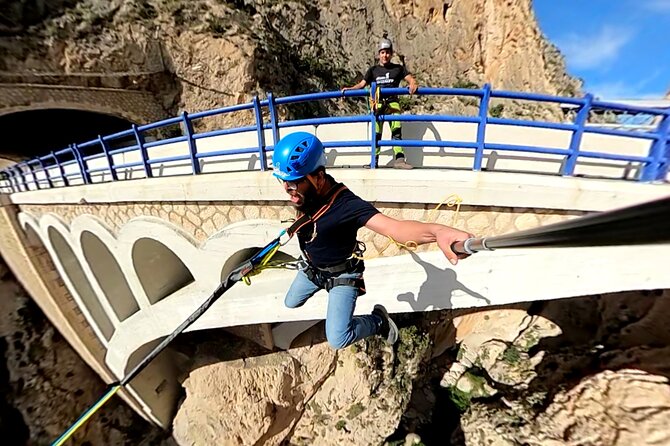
[298,185,379,268]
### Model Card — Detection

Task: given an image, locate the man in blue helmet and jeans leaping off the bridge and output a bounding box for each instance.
[272,132,471,349]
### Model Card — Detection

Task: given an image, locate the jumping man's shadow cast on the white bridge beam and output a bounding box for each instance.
[397,251,491,311]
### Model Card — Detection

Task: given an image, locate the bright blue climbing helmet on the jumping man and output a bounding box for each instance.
[272,132,326,181]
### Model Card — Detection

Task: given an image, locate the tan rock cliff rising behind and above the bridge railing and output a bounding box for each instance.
[0,0,580,128]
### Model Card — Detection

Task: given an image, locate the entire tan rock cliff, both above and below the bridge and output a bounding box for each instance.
[7,0,670,445]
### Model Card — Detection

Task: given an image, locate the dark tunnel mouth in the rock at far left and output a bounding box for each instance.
[0,108,133,159]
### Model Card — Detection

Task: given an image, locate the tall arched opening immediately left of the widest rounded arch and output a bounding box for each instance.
[81,231,140,321]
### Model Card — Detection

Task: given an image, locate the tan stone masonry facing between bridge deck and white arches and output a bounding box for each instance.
[21,201,583,257]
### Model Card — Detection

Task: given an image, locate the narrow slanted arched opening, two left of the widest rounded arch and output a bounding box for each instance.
[48,227,114,341]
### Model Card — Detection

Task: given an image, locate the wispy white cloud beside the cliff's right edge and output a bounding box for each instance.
[556,25,636,70]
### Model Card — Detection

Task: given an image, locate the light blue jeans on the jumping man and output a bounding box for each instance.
[284,271,382,349]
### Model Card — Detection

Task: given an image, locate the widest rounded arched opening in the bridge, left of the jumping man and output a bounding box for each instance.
[132,238,195,304]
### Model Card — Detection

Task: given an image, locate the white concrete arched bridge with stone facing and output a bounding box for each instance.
[0,115,670,426]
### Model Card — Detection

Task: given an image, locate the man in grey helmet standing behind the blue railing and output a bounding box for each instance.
[342,33,419,169]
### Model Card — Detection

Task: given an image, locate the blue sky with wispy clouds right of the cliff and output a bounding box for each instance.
[533,0,670,99]
